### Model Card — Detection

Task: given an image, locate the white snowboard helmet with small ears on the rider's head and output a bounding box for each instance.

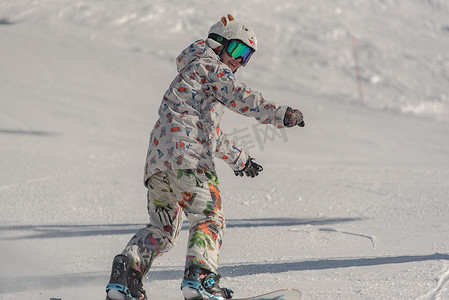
[207,14,257,51]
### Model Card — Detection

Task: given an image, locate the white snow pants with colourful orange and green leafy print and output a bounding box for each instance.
[122,170,225,275]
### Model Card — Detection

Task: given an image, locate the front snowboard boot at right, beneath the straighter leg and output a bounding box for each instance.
[181,266,234,300]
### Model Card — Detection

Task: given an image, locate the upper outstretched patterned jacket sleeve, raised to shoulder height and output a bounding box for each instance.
[209,63,288,128]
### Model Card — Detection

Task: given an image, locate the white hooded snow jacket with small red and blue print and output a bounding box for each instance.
[144,40,287,183]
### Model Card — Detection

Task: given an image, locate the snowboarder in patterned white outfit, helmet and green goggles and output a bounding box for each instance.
[106,14,304,300]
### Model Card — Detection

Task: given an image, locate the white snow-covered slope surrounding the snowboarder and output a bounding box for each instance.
[0,0,449,300]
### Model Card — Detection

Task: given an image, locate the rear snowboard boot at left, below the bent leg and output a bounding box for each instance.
[106,255,147,300]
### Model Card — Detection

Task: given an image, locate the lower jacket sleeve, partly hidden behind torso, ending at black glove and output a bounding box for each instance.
[215,130,249,171]
